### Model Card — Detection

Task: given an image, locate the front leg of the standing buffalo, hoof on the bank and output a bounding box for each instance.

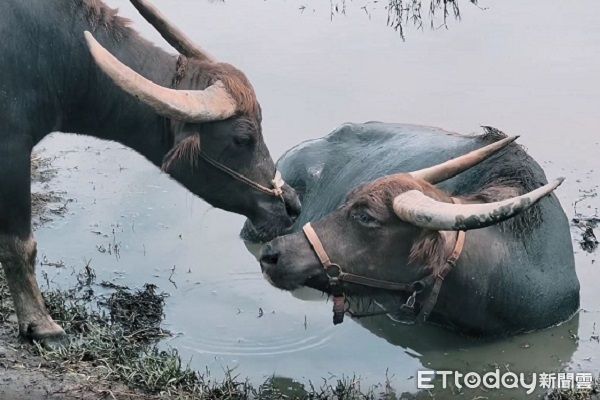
[0,135,65,341]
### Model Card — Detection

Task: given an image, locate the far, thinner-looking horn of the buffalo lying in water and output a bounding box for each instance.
[410,136,519,185]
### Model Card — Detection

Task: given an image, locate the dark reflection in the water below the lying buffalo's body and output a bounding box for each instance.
[355,296,579,372]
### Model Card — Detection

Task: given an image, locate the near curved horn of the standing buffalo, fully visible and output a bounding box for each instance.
[85,31,237,122]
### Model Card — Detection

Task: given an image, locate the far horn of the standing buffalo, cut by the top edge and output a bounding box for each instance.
[130,0,215,62]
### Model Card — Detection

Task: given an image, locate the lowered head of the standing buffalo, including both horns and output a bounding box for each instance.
[85,0,300,235]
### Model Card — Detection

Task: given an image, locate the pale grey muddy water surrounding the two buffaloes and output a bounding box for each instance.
[37,0,600,397]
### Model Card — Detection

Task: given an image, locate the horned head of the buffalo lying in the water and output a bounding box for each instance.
[260,137,562,295]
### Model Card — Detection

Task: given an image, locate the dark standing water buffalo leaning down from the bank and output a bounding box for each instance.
[0,0,300,340]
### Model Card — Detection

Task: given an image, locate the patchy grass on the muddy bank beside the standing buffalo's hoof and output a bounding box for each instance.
[0,265,404,400]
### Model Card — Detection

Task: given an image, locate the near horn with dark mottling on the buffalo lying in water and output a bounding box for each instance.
[394,178,565,231]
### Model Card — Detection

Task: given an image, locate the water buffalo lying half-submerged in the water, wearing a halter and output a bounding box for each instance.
[243,123,579,335]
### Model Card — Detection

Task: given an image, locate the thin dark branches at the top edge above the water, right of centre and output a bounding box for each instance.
[330,0,478,39]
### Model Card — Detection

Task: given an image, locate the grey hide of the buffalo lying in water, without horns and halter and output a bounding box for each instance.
[242,122,579,335]
